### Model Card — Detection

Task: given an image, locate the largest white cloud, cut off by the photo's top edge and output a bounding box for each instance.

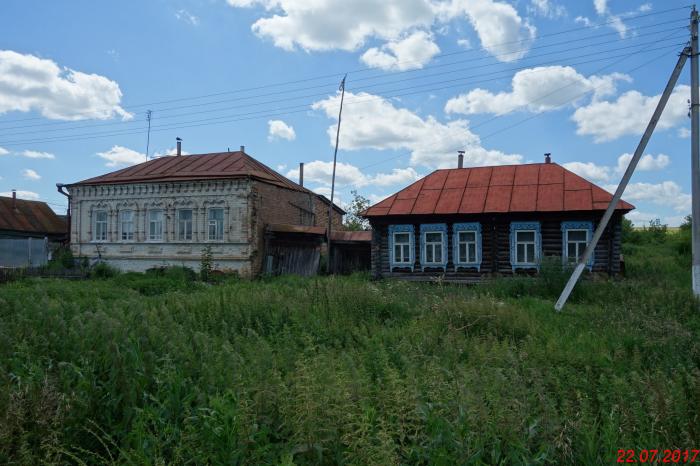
[228,0,535,61]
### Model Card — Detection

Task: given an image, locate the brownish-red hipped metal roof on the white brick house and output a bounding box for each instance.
[70,151,308,192]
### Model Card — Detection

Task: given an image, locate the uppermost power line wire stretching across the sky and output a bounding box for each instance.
[0,5,690,124]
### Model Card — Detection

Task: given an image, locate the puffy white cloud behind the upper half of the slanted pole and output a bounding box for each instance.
[571,85,690,142]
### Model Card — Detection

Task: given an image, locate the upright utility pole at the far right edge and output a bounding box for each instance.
[690,5,700,298]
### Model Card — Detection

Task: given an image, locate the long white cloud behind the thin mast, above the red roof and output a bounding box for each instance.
[312,92,522,168]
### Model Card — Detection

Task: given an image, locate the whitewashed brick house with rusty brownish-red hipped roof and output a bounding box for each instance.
[67,151,344,276]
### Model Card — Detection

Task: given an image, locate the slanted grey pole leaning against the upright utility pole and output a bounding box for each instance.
[554,45,699,311]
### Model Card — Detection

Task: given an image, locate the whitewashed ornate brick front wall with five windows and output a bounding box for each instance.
[69,178,258,276]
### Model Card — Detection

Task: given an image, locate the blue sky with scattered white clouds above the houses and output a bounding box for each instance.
[0,0,691,226]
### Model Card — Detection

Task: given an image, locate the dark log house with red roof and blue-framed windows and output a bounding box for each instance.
[363,162,634,283]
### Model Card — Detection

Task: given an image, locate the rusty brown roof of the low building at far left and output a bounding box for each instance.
[0,197,67,235]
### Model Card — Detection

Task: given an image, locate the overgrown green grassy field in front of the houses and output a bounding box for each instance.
[0,228,700,465]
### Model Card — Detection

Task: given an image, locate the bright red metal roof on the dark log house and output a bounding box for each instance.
[363,163,634,217]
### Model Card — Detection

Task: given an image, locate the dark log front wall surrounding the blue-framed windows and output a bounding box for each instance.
[371,214,621,282]
